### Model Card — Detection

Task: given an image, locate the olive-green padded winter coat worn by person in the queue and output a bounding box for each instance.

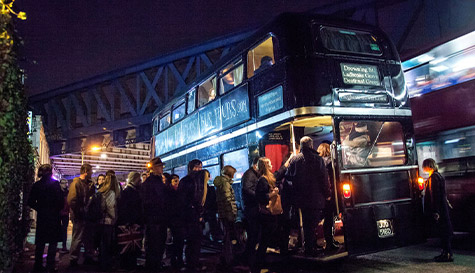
[213,175,237,223]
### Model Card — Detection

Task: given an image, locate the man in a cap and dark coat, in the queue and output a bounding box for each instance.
[141,156,167,271]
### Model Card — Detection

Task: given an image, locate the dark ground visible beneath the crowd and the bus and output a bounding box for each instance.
[13,221,475,273]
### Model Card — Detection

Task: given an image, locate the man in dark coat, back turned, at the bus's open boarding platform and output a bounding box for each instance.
[285,137,330,256]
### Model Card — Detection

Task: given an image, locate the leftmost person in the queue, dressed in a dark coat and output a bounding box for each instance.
[28,164,64,272]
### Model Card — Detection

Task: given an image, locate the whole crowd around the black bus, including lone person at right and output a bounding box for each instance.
[28,137,452,272]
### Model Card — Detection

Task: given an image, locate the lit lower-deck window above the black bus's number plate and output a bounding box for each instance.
[339,120,407,168]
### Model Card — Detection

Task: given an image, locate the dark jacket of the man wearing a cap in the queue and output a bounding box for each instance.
[140,174,166,225]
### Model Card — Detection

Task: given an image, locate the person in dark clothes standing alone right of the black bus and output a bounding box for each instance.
[422,158,454,262]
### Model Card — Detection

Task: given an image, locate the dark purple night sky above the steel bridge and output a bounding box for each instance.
[15,0,330,95]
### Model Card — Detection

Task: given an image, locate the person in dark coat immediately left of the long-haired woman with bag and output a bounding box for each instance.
[241,156,259,265]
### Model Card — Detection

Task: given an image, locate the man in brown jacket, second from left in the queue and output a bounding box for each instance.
[68,164,95,267]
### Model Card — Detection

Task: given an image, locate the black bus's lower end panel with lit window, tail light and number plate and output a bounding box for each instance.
[335,119,423,255]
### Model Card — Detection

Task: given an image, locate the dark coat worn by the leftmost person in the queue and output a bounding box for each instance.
[28,178,64,244]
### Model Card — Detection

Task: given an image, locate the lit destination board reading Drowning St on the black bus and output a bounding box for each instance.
[340,63,381,86]
